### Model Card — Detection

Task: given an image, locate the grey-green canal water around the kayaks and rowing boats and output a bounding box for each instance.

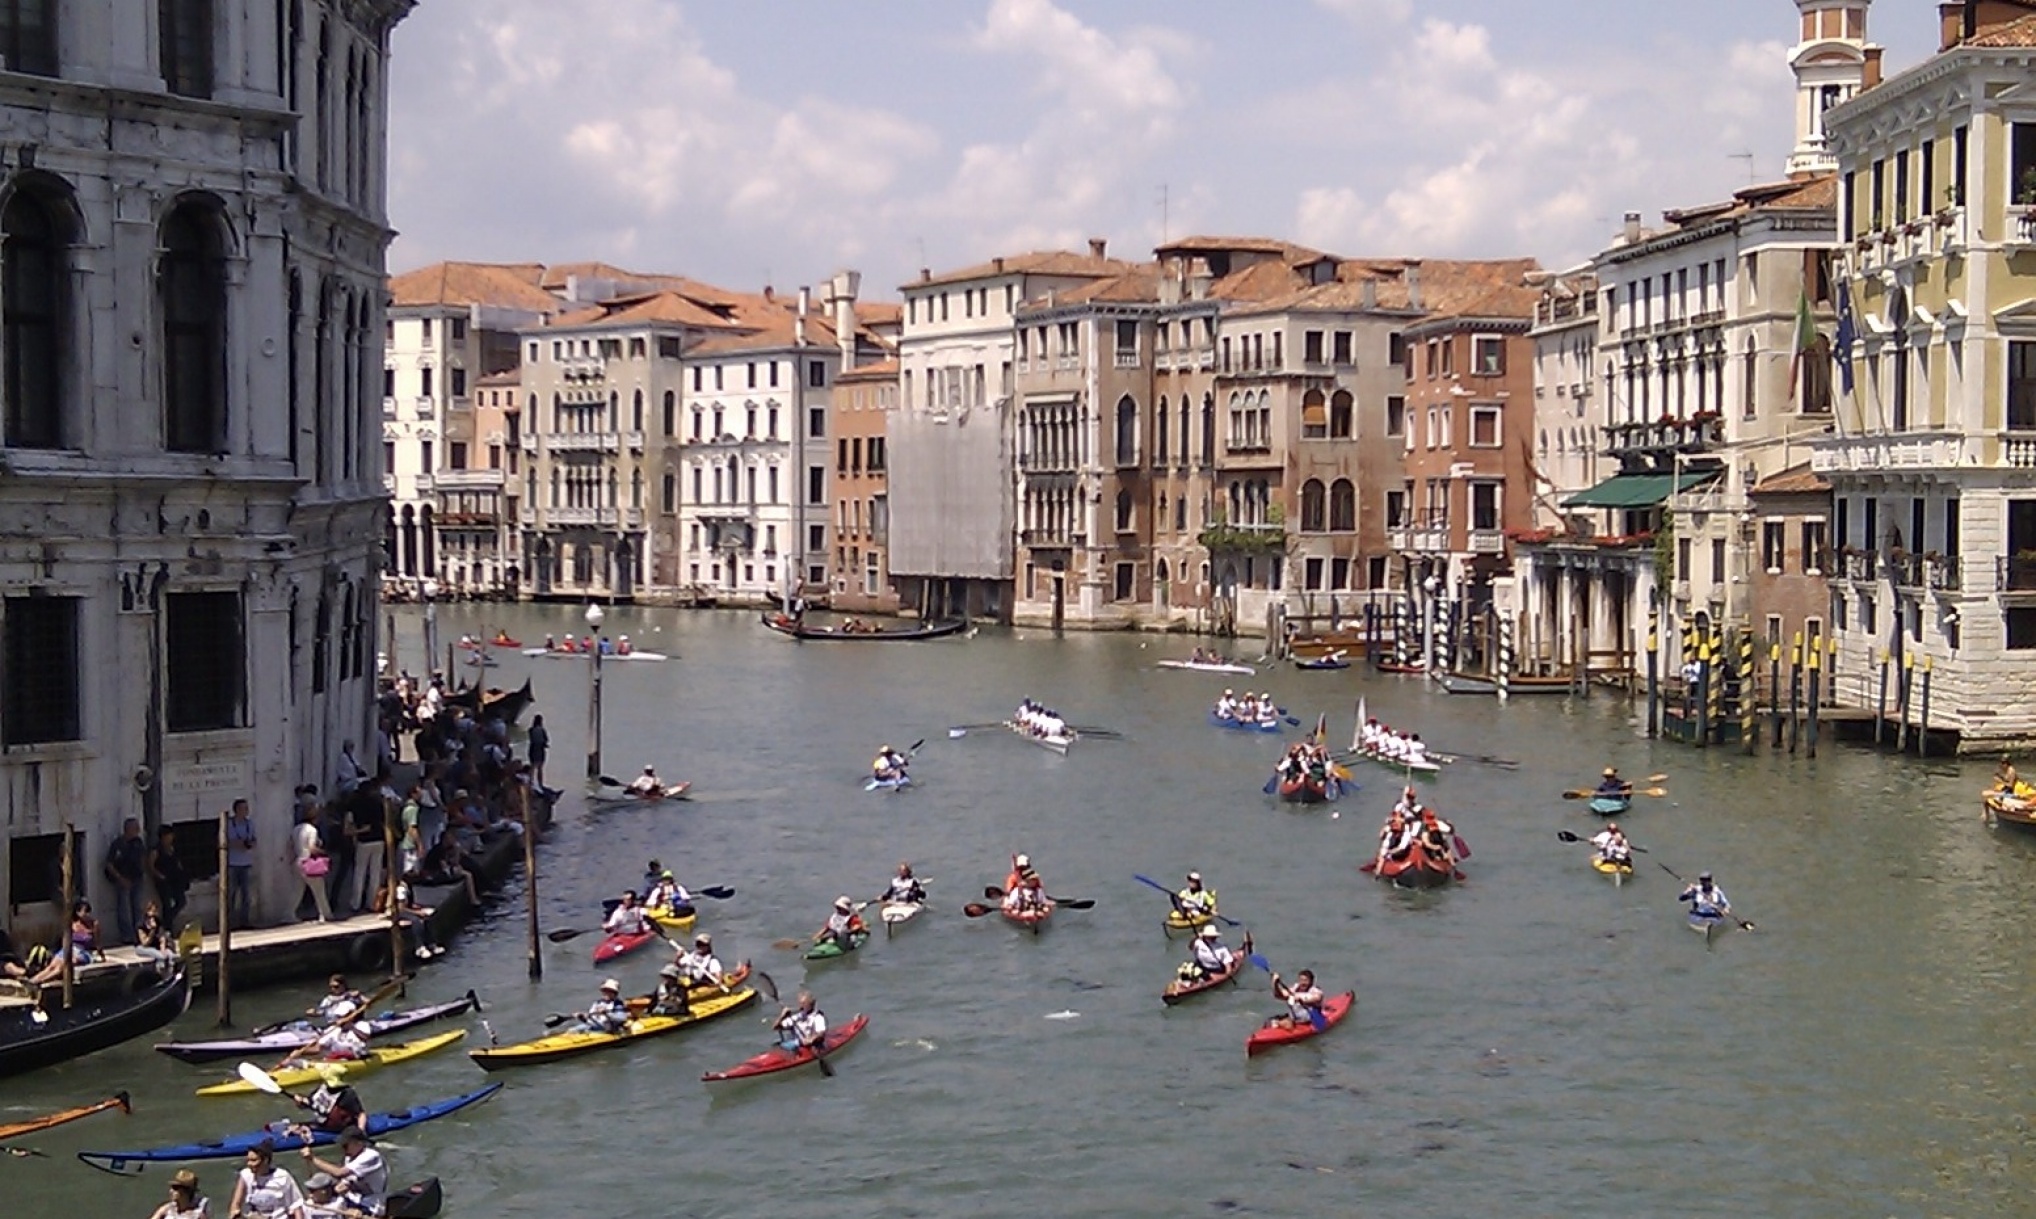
[0,606,2036,1219]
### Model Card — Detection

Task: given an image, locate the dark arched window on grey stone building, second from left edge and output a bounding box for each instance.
[157,199,228,454]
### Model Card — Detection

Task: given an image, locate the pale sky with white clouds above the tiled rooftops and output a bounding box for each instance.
[389,0,1936,299]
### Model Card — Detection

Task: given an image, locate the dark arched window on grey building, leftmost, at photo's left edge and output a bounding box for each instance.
[0,189,69,448]
